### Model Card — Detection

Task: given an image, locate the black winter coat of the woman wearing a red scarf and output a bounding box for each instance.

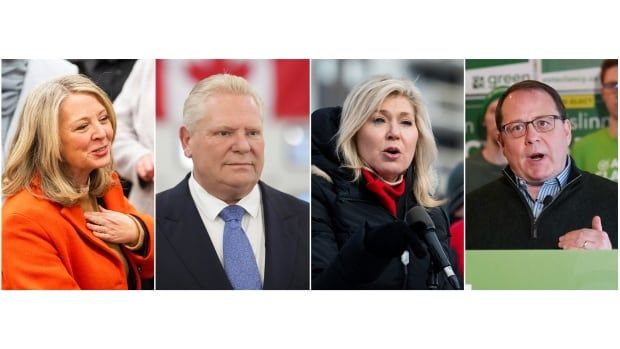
[311,108,456,289]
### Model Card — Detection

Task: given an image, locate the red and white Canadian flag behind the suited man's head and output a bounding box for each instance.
[157,59,310,122]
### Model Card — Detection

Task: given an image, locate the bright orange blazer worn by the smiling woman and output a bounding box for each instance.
[2,173,154,290]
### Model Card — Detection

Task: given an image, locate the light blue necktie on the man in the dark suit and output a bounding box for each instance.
[219,205,261,290]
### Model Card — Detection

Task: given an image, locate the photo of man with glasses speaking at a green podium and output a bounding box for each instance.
[465,59,618,290]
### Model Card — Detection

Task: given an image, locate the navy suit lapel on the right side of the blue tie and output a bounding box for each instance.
[259,182,298,290]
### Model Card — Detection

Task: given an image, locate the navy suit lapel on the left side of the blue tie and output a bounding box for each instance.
[158,177,232,289]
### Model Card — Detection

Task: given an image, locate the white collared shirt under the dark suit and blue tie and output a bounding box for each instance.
[188,171,265,283]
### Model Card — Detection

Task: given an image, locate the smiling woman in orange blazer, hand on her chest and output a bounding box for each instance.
[2,75,154,289]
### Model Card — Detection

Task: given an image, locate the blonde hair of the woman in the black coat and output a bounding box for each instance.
[336,75,442,207]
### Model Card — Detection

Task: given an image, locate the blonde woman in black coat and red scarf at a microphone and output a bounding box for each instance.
[312,76,454,289]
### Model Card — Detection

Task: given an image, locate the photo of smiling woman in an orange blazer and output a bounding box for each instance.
[2,59,155,290]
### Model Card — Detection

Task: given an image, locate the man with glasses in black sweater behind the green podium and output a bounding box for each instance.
[465,80,618,250]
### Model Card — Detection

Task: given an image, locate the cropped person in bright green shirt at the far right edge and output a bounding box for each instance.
[571,59,618,182]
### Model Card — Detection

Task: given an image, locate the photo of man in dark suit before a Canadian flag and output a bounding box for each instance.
[156,59,310,290]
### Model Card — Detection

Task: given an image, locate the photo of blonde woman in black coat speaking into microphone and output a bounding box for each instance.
[311,59,463,290]
